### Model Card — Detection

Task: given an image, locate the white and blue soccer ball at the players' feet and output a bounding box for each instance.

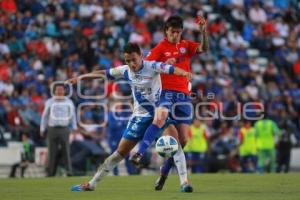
[155,135,178,157]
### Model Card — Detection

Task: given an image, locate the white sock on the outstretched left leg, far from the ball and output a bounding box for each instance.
[89,151,123,187]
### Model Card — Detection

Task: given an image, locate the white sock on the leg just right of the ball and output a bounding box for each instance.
[173,145,188,185]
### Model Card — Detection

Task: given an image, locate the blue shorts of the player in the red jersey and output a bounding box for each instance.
[158,90,193,125]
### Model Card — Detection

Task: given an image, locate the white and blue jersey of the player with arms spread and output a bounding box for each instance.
[106,60,174,117]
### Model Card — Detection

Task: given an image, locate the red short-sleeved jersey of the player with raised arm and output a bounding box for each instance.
[146,39,199,94]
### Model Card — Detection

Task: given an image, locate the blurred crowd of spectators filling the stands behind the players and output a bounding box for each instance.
[0,0,300,173]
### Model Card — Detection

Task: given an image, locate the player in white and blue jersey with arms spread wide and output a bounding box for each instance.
[66,43,191,191]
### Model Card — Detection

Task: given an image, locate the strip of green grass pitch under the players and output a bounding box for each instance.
[0,173,300,200]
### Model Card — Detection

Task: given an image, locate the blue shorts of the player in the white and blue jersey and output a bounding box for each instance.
[122,116,174,142]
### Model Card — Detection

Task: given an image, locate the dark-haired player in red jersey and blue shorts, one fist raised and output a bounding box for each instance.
[131,16,208,192]
